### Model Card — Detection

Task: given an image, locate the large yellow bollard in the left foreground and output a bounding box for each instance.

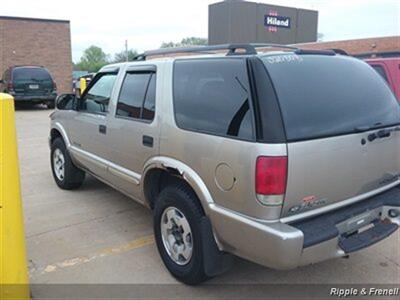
[0,93,29,299]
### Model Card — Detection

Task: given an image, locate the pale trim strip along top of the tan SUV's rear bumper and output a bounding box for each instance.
[280,179,400,223]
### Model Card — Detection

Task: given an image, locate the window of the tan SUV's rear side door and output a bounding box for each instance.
[116,72,156,121]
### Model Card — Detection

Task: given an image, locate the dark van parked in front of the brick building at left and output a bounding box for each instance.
[1,66,57,108]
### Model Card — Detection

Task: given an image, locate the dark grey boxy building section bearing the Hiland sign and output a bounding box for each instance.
[208,0,318,45]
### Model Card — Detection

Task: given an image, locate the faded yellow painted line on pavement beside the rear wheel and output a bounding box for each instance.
[39,235,154,274]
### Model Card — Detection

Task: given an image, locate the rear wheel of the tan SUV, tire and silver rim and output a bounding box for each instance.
[154,184,209,285]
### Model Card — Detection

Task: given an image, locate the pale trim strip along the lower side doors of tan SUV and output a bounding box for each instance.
[68,145,141,185]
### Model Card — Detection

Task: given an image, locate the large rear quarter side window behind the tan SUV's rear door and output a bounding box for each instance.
[174,58,253,139]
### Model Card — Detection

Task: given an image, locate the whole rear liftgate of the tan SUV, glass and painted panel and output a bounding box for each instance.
[262,54,400,216]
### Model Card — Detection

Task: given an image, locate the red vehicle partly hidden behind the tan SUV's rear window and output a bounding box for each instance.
[356,52,400,102]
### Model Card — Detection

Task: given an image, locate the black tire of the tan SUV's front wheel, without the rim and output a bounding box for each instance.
[50,137,85,190]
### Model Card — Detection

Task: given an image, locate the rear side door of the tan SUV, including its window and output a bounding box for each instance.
[107,65,161,199]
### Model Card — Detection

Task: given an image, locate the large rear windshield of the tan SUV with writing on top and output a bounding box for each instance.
[262,54,400,141]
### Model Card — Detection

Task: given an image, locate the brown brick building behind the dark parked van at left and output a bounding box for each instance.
[0,16,73,93]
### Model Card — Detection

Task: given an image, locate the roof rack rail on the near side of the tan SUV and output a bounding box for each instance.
[133,44,299,60]
